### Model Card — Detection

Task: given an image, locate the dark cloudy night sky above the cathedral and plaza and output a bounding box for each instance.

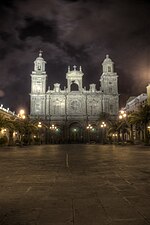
[0,0,150,111]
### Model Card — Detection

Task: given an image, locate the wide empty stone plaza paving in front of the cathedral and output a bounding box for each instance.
[0,145,150,225]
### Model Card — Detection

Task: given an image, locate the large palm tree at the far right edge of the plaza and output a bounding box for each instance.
[129,104,150,144]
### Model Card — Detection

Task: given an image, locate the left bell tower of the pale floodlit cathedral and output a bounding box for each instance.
[30,51,47,116]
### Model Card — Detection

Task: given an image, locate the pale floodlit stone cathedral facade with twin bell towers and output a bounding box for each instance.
[30,52,119,142]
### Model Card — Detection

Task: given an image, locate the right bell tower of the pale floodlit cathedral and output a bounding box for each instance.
[100,55,119,115]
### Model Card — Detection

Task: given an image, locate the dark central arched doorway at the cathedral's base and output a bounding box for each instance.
[69,122,83,143]
